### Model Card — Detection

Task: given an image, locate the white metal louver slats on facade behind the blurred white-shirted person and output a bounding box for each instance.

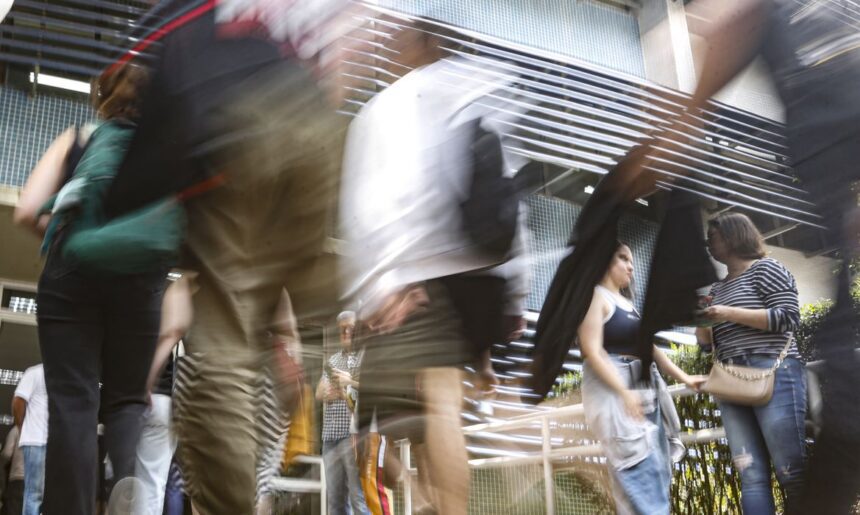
[346,9,820,227]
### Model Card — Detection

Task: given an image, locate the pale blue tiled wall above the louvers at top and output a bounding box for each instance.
[379,0,645,77]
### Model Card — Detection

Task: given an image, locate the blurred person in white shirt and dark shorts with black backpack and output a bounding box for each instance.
[340,19,527,515]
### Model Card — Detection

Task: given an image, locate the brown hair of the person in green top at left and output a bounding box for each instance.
[93,63,149,120]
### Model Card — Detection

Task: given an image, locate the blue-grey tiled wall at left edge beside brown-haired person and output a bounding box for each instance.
[0,87,94,186]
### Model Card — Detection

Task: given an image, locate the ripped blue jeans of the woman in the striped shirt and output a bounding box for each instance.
[719,356,806,515]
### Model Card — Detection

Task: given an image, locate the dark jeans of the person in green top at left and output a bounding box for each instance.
[37,253,166,515]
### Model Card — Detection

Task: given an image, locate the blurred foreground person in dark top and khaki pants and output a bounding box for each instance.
[103,2,350,515]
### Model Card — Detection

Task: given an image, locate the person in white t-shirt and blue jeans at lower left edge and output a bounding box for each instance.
[12,364,48,515]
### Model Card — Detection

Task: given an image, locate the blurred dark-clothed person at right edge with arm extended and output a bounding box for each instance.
[629,0,860,513]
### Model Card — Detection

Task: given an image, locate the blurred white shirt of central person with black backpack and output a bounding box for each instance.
[340,58,524,313]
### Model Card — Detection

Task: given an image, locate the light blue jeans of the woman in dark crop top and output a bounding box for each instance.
[612,406,672,515]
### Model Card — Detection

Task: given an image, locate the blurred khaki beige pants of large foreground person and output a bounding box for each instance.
[175,62,345,515]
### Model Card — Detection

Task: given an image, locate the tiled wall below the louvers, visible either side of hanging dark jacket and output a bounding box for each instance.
[526,195,658,311]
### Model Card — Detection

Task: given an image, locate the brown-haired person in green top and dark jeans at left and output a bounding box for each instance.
[16,64,167,515]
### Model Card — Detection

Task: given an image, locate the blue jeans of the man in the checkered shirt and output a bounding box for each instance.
[323,437,370,515]
